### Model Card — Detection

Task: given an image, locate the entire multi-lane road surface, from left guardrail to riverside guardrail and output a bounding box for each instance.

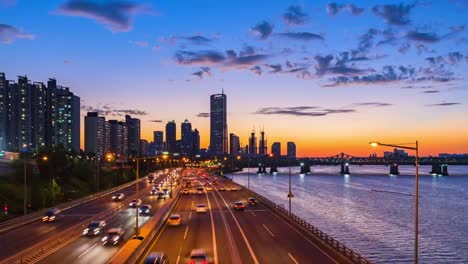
[0,169,370,264]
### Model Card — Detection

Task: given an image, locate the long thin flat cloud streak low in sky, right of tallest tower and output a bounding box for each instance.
[253,106,356,117]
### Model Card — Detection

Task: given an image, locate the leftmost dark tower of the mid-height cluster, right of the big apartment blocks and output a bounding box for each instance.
[84,112,107,158]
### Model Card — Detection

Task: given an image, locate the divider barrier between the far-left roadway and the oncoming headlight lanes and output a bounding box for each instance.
[0,173,165,264]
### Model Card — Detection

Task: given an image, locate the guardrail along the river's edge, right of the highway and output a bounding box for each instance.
[233,179,371,264]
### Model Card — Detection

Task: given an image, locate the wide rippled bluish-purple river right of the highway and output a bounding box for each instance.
[226,166,468,263]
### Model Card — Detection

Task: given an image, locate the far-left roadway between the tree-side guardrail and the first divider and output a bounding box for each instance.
[0,170,167,263]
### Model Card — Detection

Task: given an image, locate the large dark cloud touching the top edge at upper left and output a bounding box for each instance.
[56,0,154,32]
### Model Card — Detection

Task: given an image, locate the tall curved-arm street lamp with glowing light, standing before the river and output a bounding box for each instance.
[369,140,419,264]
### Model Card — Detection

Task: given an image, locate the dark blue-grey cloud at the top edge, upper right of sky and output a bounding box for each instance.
[372,3,416,26]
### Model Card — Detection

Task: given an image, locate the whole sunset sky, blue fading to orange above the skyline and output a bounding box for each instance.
[0,0,468,156]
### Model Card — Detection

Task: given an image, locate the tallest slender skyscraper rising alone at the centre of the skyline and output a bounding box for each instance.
[210,93,228,155]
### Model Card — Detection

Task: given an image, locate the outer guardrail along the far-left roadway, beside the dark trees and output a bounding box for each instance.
[0,176,152,234]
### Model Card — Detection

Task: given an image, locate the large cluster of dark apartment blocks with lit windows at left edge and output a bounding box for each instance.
[0,73,80,152]
